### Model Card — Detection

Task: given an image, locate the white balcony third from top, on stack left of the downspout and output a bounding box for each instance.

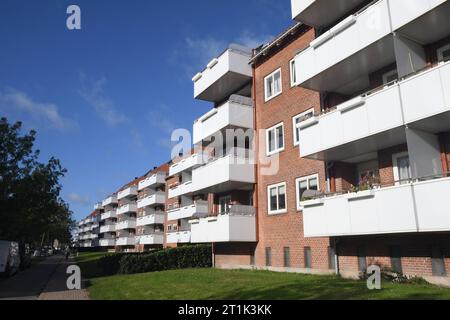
[192,154,255,193]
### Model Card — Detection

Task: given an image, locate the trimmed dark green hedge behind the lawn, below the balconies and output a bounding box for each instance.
[118,245,212,274]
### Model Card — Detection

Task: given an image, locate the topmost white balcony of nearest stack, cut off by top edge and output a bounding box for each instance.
[291,0,365,27]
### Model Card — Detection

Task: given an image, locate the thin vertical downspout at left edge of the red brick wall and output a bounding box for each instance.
[252,49,259,264]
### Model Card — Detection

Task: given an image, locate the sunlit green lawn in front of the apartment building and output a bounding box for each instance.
[89,269,450,300]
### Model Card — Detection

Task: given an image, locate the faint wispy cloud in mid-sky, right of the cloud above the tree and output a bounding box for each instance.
[79,73,128,126]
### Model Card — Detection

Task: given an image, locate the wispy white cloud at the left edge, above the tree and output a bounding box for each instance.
[0,88,77,131]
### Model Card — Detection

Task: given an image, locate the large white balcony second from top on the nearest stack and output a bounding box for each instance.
[295,0,450,95]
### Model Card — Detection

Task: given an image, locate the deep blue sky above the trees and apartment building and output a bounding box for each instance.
[0,0,291,219]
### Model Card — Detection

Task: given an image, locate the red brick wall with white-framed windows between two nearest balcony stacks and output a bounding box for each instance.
[255,27,329,269]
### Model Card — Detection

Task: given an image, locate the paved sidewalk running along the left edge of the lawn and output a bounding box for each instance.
[38,259,89,300]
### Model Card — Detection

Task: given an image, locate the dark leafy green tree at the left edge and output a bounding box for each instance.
[0,118,74,248]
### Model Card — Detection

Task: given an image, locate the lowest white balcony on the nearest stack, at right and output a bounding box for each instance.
[303,178,450,237]
